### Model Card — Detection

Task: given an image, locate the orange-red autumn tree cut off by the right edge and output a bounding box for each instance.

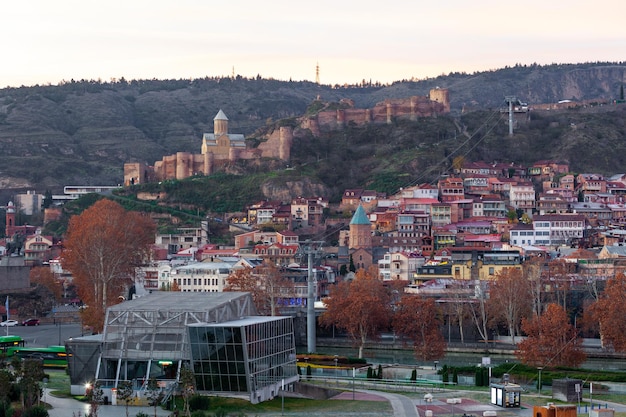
[591,273,626,352]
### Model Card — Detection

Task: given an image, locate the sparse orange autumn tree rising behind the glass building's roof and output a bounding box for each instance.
[224,261,295,316]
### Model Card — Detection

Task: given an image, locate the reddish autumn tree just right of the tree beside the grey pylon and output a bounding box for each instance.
[393,294,446,361]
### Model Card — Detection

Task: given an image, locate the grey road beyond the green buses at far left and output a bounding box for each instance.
[0,324,86,347]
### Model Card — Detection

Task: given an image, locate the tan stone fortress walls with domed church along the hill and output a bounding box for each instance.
[124,88,450,186]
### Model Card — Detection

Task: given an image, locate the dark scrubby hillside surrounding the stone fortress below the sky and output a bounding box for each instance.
[0,63,626,196]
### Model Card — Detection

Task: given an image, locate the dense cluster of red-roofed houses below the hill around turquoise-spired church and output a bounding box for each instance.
[47,161,626,306]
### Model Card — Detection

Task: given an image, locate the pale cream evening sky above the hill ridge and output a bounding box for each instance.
[0,0,626,87]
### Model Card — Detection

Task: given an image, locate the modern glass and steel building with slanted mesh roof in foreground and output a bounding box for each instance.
[77,292,298,403]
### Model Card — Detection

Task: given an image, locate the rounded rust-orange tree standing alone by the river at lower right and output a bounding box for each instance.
[515,303,586,367]
